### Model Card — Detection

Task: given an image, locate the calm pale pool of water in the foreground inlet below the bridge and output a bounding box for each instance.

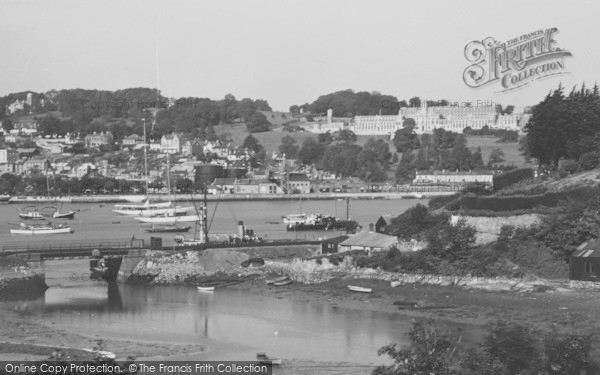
[4,262,482,364]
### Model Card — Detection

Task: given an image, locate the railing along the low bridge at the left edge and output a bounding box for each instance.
[0,240,146,252]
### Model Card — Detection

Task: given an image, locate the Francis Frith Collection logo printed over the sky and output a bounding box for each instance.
[463,27,572,92]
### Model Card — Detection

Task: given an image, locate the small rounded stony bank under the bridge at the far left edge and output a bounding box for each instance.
[0,256,48,301]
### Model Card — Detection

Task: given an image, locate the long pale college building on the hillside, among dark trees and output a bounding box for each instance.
[307,101,524,137]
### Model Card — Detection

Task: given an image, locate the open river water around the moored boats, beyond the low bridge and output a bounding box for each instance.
[0,199,427,244]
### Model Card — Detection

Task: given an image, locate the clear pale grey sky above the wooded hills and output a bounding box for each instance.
[0,0,600,111]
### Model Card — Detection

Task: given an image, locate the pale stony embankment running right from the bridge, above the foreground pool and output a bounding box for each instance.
[125,246,590,292]
